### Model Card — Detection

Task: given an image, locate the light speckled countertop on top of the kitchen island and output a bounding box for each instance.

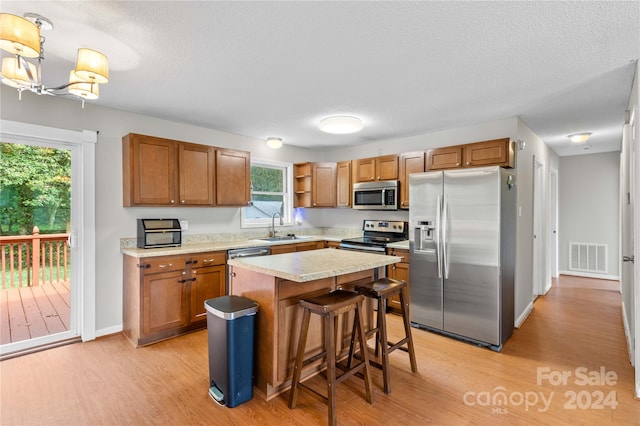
[227,249,402,282]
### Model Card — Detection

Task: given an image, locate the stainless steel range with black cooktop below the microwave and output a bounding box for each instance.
[340,220,409,254]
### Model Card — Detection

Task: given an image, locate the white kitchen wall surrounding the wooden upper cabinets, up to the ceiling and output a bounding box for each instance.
[0,86,555,335]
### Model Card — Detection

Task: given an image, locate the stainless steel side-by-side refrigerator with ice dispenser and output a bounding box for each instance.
[409,167,516,351]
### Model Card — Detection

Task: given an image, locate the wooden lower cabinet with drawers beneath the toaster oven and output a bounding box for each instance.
[123,251,226,347]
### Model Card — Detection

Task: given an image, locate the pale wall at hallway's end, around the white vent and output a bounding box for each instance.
[558,152,620,279]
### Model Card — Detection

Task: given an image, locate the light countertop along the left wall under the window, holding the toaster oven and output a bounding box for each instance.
[120,235,345,258]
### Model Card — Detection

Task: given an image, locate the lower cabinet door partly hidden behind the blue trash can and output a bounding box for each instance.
[189,265,226,323]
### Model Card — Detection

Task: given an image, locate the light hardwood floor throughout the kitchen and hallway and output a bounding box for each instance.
[0,276,640,425]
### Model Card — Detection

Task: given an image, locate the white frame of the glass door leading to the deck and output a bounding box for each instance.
[0,120,97,357]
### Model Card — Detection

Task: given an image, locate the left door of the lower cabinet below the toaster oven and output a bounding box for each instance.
[141,271,188,337]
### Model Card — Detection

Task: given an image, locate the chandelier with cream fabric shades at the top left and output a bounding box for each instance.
[0,13,109,108]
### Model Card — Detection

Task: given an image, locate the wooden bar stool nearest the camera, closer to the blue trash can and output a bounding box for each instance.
[289,290,373,425]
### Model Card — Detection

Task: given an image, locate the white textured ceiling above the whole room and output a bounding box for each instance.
[0,1,640,155]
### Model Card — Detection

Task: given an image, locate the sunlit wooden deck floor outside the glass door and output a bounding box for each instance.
[0,281,71,345]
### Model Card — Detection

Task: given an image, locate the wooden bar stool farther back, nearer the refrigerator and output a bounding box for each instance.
[349,278,418,394]
